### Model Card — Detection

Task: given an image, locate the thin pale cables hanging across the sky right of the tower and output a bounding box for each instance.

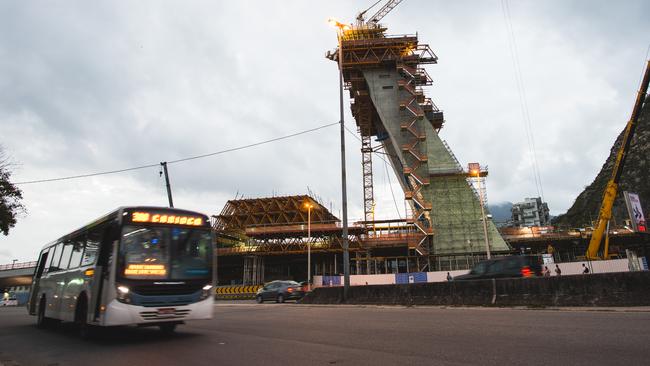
[501,0,545,202]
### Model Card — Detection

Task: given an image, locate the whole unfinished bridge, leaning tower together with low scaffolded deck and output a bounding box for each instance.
[214,12,511,284]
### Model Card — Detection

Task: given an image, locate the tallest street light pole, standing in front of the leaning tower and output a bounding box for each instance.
[328,18,350,300]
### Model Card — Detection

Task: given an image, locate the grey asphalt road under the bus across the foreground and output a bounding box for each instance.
[0,303,650,366]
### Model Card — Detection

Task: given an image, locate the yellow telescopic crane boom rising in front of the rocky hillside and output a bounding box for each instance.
[586,60,650,259]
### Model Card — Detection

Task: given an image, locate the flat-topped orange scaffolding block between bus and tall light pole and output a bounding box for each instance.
[212,195,366,285]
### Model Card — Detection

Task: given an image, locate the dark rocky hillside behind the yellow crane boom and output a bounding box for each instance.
[553,93,650,227]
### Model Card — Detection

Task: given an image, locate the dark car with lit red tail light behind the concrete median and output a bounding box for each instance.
[454,255,542,281]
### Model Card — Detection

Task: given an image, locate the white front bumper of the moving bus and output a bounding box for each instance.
[100,297,214,326]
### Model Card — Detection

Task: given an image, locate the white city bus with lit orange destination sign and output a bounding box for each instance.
[27,207,214,337]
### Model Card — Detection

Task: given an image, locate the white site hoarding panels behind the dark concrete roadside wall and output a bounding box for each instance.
[313,259,641,287]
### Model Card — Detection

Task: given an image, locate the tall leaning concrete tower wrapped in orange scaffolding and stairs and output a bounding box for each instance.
[327,24,510,268]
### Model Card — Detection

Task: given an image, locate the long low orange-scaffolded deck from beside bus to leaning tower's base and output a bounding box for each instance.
[212,195,506,285]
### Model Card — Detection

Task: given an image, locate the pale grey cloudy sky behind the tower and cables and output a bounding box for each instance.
[0,0,650,264]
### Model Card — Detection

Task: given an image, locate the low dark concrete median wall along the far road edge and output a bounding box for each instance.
[301,272,650,306]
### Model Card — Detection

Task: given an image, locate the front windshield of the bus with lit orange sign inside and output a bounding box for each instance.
[118,225,212,280]
